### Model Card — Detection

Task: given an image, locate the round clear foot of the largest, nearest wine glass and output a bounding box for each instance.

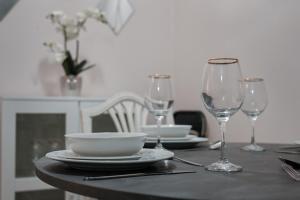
[205,159,243,172]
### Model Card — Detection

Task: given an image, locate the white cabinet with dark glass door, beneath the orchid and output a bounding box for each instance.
[0,97,104,200]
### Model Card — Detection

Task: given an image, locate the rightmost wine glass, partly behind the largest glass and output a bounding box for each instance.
[241,78,268,151]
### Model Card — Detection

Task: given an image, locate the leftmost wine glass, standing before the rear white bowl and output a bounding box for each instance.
[145,74,174,149]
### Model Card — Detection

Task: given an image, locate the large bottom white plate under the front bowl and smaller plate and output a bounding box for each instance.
[46,149,174,171]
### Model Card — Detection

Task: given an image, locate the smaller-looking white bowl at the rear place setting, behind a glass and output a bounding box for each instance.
[141,125,192,137]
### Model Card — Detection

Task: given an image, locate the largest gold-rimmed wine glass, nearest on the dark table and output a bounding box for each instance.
[201,58,244,172]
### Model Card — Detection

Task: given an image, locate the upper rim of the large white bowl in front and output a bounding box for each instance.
[65,132,147,139]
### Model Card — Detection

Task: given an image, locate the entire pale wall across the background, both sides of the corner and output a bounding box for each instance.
[0,0,300,142]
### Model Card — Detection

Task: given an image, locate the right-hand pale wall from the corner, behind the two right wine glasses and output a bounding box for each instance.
[174,0,300,142]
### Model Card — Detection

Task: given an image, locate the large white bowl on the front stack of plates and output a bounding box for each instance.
[65,132,146,157]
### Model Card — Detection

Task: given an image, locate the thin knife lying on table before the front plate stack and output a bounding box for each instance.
[83,171,196,181]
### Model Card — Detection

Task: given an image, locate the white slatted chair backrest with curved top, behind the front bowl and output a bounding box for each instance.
[81,92,174,132]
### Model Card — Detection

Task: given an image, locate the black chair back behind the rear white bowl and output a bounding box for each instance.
[173,110,206,137]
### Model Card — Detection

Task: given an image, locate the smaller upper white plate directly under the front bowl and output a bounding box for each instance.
[51,150,142,160]
